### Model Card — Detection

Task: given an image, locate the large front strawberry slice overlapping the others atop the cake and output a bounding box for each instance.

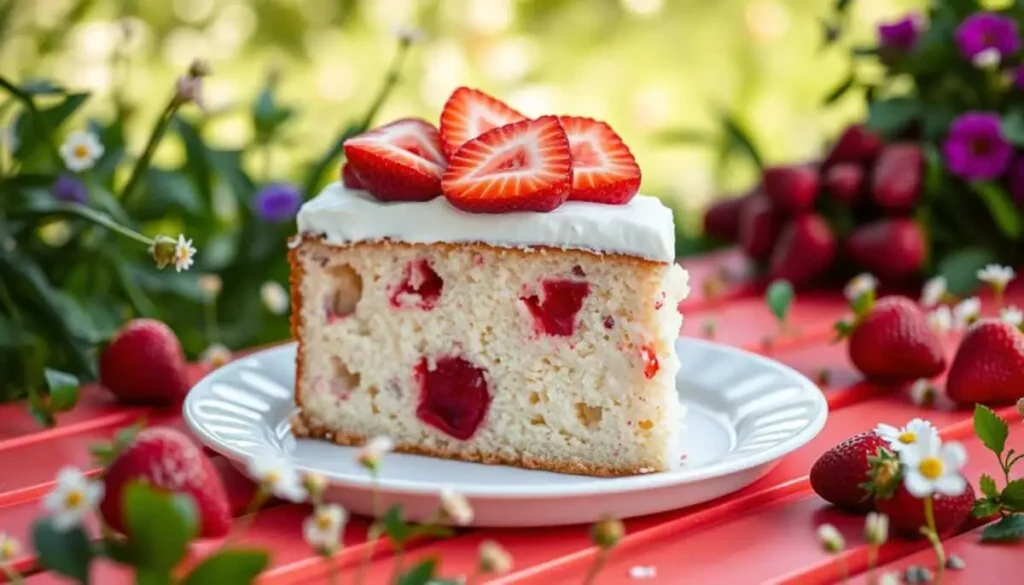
[441,116,572,213]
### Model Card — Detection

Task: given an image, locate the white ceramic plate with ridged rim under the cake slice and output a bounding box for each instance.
[184,338,828,527]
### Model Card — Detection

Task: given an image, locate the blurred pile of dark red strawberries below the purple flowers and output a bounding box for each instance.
[705,126,927,286]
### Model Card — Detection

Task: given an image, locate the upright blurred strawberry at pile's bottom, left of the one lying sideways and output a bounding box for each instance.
[769,214,836,286]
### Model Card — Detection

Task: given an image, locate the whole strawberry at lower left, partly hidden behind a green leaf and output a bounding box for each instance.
[99,427,231,538]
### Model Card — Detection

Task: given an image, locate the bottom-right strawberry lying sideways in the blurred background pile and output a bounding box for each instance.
[846,217,927,279]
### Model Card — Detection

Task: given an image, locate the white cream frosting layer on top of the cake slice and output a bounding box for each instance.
[298,181,676,262]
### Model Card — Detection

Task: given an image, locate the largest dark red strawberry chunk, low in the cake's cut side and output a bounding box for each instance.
[415,357,490,441]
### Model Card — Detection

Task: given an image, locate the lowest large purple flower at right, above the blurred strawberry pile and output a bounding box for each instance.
[942,112,1014,180]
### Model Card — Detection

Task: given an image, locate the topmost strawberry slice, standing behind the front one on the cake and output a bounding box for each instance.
[440,87,526,159]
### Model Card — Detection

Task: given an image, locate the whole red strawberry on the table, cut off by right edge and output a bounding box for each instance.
[946,319,1024,405]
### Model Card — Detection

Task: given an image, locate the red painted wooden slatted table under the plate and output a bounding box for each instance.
[0,251,1024,585]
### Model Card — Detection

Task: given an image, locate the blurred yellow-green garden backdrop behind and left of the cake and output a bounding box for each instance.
[0,0,925,403]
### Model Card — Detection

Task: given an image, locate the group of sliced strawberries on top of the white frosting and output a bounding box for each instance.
[341,87,640,213]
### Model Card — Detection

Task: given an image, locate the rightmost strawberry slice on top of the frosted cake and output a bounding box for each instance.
[558,116,640,205]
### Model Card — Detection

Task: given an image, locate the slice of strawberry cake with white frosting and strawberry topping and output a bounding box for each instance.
[290,88,689,475]
